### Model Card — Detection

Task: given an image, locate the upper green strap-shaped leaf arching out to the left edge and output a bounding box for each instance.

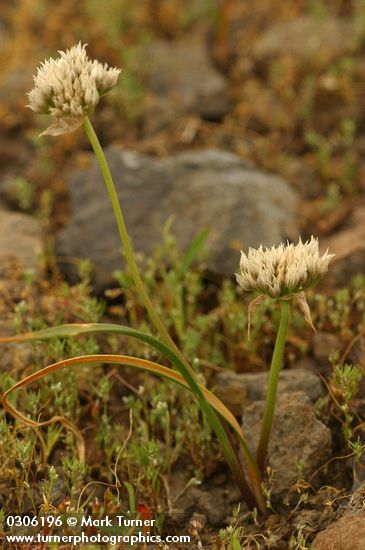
[0,323,265,510]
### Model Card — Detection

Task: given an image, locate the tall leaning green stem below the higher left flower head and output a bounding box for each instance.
[84,117,265,512]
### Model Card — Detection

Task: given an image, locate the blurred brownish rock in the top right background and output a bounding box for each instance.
[252,15,360,64]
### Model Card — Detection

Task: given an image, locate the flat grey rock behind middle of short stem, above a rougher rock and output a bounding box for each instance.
[215,369,322,416]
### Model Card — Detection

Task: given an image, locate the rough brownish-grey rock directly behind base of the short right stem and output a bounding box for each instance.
[242,392,331,503]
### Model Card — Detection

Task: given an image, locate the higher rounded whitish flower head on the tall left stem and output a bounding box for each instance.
[28,42,121,136]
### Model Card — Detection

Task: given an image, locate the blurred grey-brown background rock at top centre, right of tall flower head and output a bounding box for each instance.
[142,41,230,131]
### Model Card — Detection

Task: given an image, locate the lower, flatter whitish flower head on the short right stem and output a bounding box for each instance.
[237,237,333,298]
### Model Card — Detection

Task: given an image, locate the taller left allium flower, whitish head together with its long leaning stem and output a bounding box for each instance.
[28,43,265,512]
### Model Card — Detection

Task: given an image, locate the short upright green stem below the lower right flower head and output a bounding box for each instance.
[256,300,289,473]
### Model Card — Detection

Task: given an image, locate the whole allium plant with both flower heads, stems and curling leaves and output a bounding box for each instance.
[0,43,332,513]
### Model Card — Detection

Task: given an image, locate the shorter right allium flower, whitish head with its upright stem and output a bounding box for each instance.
[236,237,333,473]
